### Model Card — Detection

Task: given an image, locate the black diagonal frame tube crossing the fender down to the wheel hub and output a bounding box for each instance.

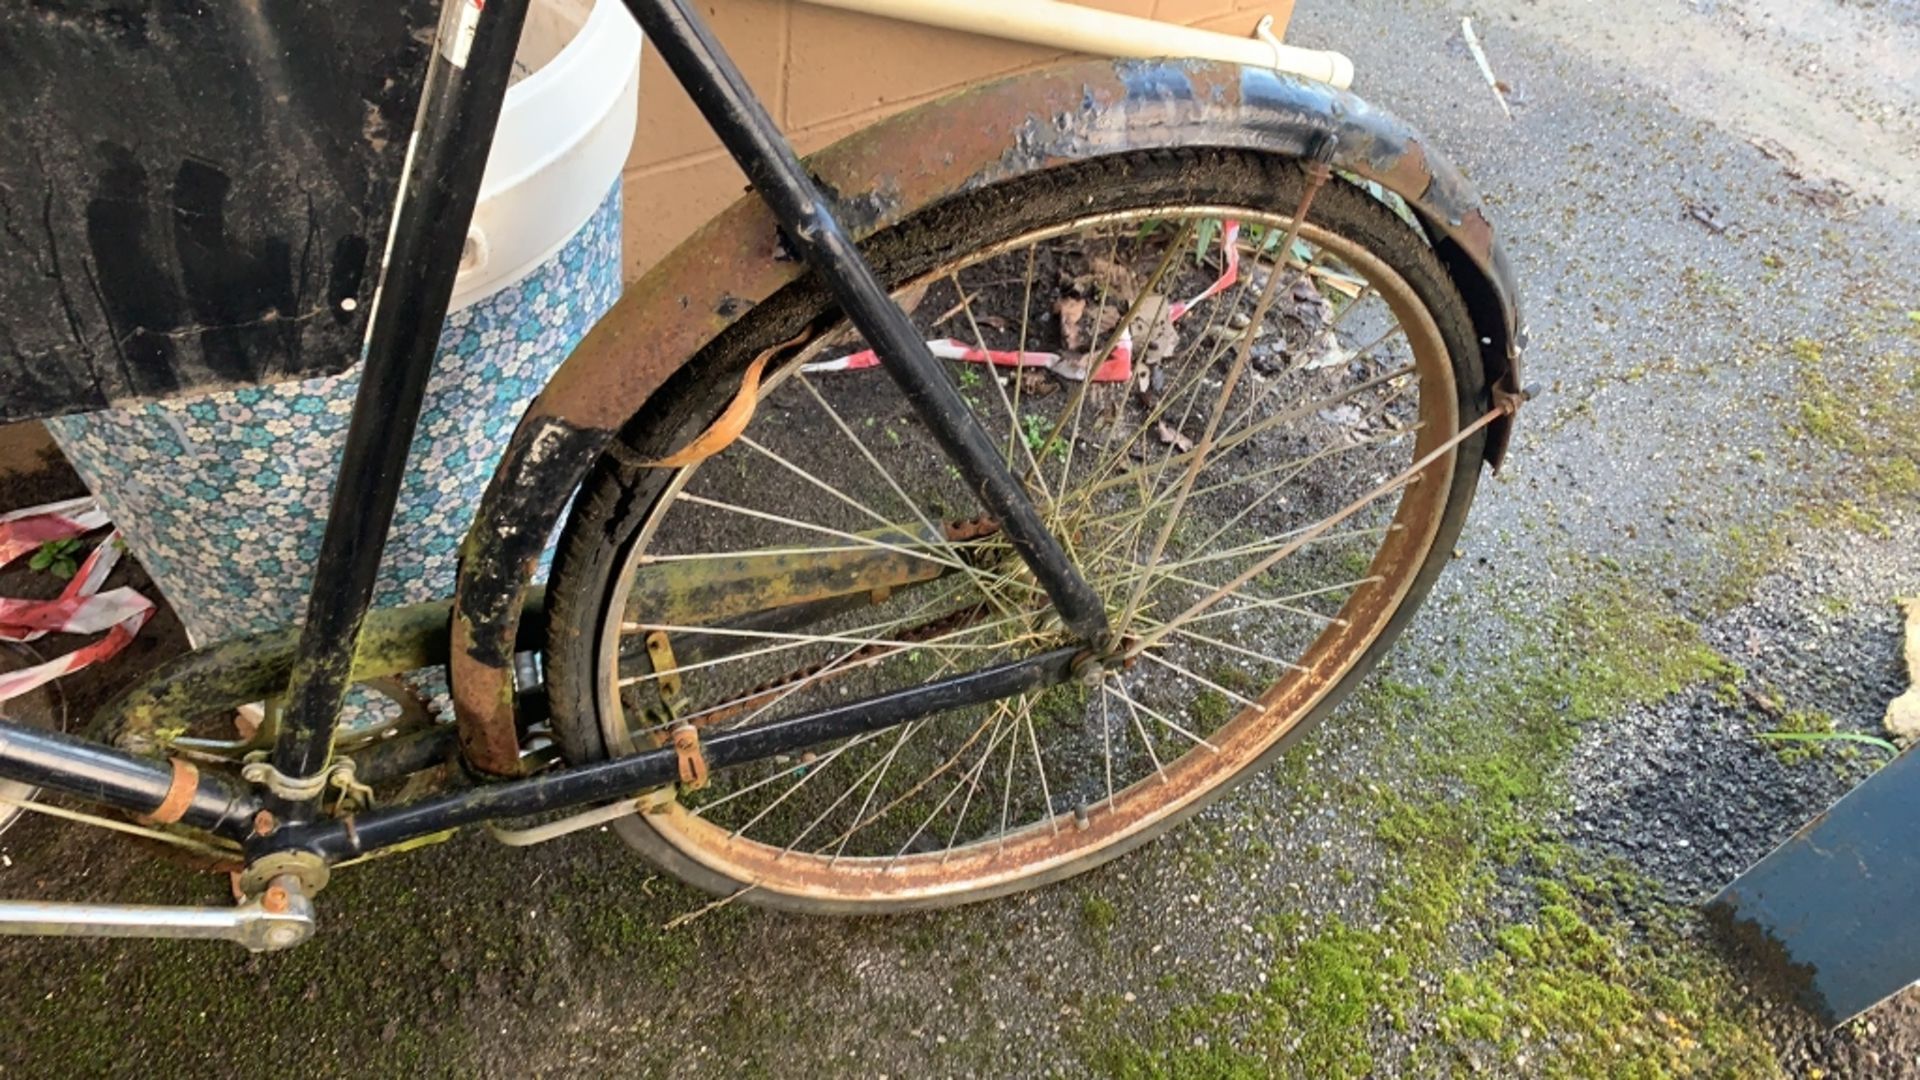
[626,0,1110,648]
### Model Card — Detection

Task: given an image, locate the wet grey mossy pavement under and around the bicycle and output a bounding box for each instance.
[0,0,1920,1076]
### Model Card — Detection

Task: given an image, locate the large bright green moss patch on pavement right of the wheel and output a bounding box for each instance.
[1098,577,1776,1076]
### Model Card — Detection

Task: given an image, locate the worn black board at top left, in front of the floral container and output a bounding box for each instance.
[0,0,438,423]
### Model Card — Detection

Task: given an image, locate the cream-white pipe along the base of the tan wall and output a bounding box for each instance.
[791,0,1354,90]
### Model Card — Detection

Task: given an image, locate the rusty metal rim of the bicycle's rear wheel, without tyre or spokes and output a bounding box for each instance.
[601,206,1459,905]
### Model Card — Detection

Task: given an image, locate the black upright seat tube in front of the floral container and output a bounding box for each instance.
[269,0,528,822]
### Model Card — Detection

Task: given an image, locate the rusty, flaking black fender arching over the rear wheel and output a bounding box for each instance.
[451,60,1521,774]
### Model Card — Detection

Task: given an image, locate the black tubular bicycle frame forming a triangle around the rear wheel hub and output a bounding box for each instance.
[0,0,1110,861]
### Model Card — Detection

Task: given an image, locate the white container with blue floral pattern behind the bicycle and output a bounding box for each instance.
[48,0,639,644]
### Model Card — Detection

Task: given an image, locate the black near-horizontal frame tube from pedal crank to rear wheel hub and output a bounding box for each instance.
[263,648,1085,863]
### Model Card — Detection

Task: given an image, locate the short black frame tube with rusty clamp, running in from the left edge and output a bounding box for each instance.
[0,721,261,840]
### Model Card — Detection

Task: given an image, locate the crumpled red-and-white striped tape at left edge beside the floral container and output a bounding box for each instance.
[0,498,154,701]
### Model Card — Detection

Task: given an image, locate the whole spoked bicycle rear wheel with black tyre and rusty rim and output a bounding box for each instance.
[549,152,1486,913]
